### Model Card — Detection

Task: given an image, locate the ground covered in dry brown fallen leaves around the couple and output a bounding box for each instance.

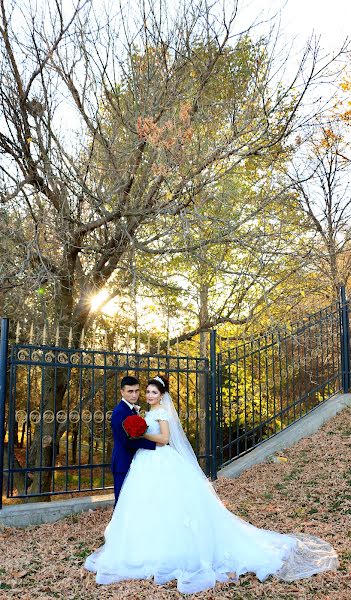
[0,409,351,600]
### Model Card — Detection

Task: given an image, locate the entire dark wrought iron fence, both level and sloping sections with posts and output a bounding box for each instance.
[0,288,350,508]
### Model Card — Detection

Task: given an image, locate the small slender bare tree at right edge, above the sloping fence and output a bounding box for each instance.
[292,120,351,298]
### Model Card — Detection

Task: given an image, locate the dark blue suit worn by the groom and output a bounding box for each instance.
[111,400,156,506]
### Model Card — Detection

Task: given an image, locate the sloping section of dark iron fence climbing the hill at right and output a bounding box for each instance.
[217,288,350,468]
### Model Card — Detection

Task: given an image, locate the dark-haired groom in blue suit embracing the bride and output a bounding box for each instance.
[111,376,156,506]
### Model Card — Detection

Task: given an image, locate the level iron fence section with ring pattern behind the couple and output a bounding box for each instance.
[0,335,210,506]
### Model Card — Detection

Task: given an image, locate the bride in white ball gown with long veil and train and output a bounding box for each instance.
[84,376,338,594]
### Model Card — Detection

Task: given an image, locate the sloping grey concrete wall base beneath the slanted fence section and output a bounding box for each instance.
[218,394,351,479]
